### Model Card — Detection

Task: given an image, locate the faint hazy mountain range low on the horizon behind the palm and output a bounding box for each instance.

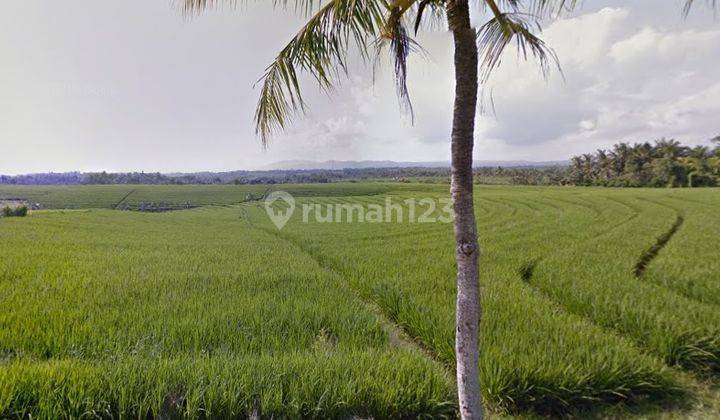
[262,160,568,170]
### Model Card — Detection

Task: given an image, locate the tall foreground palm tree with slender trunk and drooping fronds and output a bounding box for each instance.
[183,0,708,418]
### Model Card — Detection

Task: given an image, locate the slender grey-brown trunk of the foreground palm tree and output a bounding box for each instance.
[447,0,483,419]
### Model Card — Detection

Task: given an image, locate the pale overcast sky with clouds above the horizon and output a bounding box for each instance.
[0,0,720,174]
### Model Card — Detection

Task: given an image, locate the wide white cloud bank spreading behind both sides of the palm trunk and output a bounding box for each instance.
[288,7,720,160]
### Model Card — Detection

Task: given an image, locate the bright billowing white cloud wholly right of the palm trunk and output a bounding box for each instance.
[478,8,720,158]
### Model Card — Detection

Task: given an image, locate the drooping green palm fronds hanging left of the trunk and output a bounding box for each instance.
[184,0,434,146]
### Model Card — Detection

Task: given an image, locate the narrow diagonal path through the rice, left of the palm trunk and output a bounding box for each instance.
[250,224,455,378]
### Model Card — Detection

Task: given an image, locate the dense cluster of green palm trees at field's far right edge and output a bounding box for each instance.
[567,136,720,187]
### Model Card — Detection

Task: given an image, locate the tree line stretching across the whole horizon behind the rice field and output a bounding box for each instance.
[0,136,720,187]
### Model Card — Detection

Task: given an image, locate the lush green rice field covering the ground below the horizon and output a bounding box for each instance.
[0,182,720,419]
